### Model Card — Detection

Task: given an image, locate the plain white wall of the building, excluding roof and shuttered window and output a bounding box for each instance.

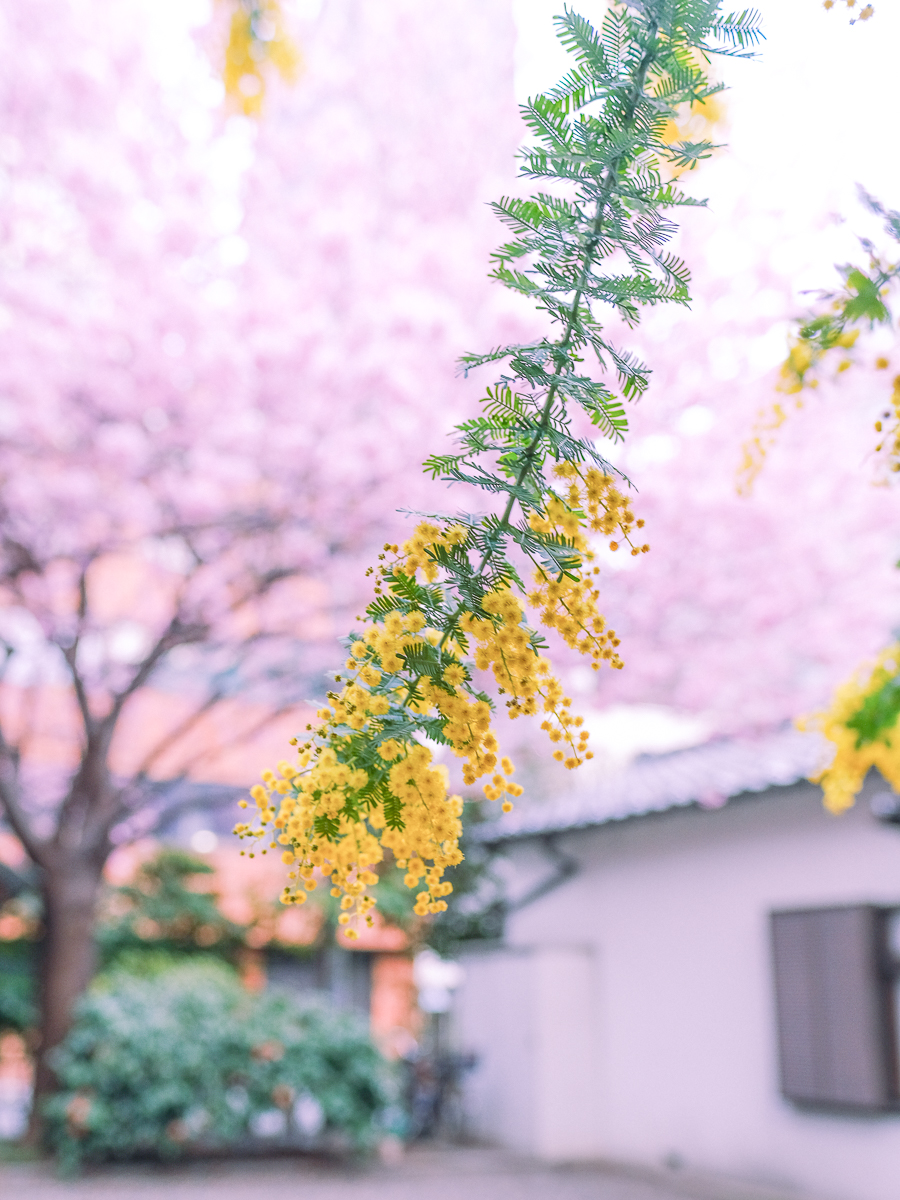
[456,785,900,1200]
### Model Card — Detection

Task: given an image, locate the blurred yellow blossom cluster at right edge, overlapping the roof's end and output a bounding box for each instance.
[802,646,900,814]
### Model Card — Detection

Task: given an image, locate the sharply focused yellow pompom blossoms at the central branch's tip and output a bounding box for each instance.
[235,462,649,937]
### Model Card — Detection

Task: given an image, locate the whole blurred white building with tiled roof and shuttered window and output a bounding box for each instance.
[454,731,900,1198]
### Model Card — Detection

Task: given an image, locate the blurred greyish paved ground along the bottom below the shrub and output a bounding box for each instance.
[0,1147,799,1200]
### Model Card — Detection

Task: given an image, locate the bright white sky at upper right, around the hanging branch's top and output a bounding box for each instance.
[514,0,900,292]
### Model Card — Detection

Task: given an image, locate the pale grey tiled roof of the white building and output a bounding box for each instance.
[473,728,828,842]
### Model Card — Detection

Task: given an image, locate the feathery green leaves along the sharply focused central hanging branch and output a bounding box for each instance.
[355,0,761,770]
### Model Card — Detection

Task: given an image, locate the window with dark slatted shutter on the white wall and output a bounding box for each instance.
[772,905,900,1112]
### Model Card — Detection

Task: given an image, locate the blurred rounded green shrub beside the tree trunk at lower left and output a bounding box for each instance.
[46,960,397,1171]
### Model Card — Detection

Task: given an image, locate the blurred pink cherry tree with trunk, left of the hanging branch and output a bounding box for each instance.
[0,0,517,1108]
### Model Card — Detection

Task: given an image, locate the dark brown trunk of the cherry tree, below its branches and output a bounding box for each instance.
[30,854,103,1140]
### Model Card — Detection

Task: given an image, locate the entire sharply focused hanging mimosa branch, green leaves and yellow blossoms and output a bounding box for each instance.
[236,0,760,936]
